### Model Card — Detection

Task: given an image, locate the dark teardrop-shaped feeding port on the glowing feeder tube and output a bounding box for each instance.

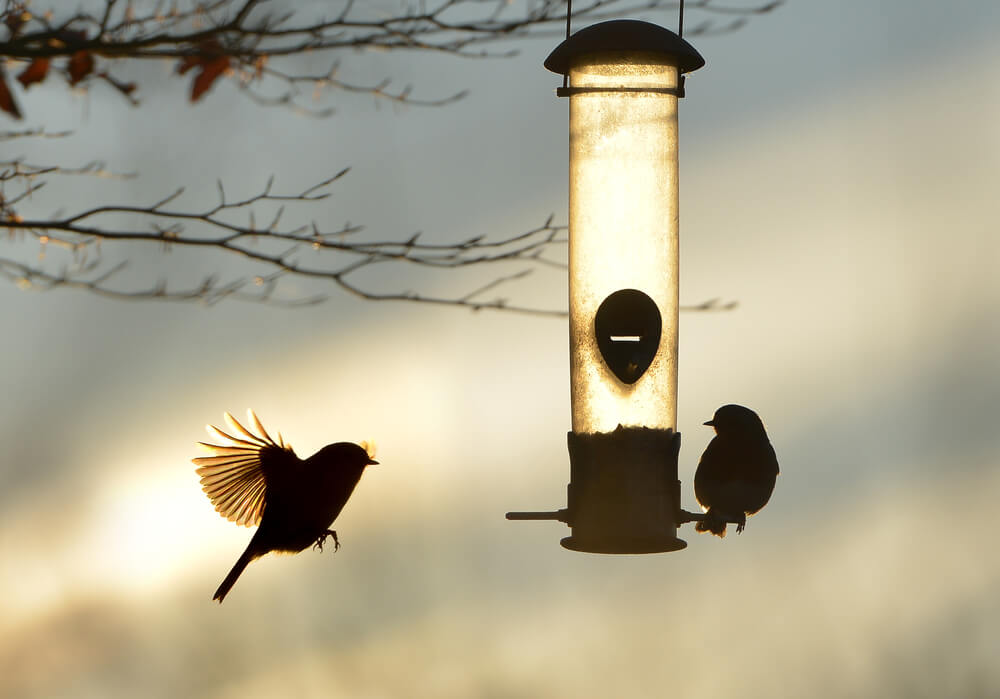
[594,289,662,384]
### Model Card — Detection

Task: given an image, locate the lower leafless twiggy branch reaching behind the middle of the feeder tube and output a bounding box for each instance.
[0,165,735,316]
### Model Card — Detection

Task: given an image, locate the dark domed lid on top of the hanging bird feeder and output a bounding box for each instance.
[544,19,705,75]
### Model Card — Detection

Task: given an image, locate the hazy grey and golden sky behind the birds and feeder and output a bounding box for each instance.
[0,0,1000,699]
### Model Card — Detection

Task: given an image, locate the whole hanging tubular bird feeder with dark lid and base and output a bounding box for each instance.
[507,20,705,553]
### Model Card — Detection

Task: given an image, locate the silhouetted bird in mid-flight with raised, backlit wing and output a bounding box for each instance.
[192,410,378,604]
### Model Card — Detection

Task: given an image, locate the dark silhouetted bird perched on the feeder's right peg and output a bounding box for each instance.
[694,405,778,536]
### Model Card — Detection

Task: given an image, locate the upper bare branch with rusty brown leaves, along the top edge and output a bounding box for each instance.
[0,0,780,116]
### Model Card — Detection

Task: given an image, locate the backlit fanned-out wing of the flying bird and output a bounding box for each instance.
[191,410,298,527]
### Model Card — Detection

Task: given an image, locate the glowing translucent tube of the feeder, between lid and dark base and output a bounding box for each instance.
[569,54,679,434]
